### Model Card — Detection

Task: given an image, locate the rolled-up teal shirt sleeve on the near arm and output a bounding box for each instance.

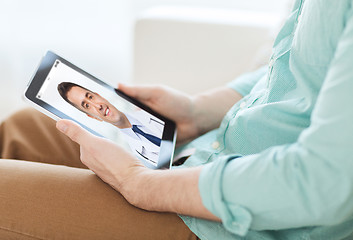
[199,7,353,235]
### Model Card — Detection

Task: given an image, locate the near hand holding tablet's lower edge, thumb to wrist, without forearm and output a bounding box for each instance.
[56,120,149,197]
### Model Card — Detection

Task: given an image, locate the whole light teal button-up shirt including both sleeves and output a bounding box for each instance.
[177,0,353,240]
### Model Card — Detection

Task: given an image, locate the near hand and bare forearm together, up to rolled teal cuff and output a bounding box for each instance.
[56,120,219,221]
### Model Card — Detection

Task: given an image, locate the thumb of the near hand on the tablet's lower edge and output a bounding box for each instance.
[56,120,93,145]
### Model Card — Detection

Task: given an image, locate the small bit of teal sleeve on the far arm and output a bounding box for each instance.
[227,66,268,96]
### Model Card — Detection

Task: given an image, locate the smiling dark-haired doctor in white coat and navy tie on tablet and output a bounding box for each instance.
[58,82,164,165]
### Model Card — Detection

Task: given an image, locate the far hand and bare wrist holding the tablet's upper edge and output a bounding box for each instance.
[118,84,242,144]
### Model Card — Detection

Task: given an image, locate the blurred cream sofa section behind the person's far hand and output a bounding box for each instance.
[133,7,280,93]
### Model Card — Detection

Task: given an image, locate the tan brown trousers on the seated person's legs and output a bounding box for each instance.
[0,109,198,240]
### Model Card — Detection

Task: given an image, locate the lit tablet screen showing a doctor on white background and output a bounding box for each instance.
[36,60,165,167]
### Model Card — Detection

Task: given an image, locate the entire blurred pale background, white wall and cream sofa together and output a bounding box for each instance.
[0,0,291,119]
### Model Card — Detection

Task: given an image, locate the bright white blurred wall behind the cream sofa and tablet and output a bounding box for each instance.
[0,0,284,119]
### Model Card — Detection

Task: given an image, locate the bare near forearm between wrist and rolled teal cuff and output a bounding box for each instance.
[121,167,220,221]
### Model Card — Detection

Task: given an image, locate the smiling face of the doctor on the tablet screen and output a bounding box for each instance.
[67,86,124,124]
